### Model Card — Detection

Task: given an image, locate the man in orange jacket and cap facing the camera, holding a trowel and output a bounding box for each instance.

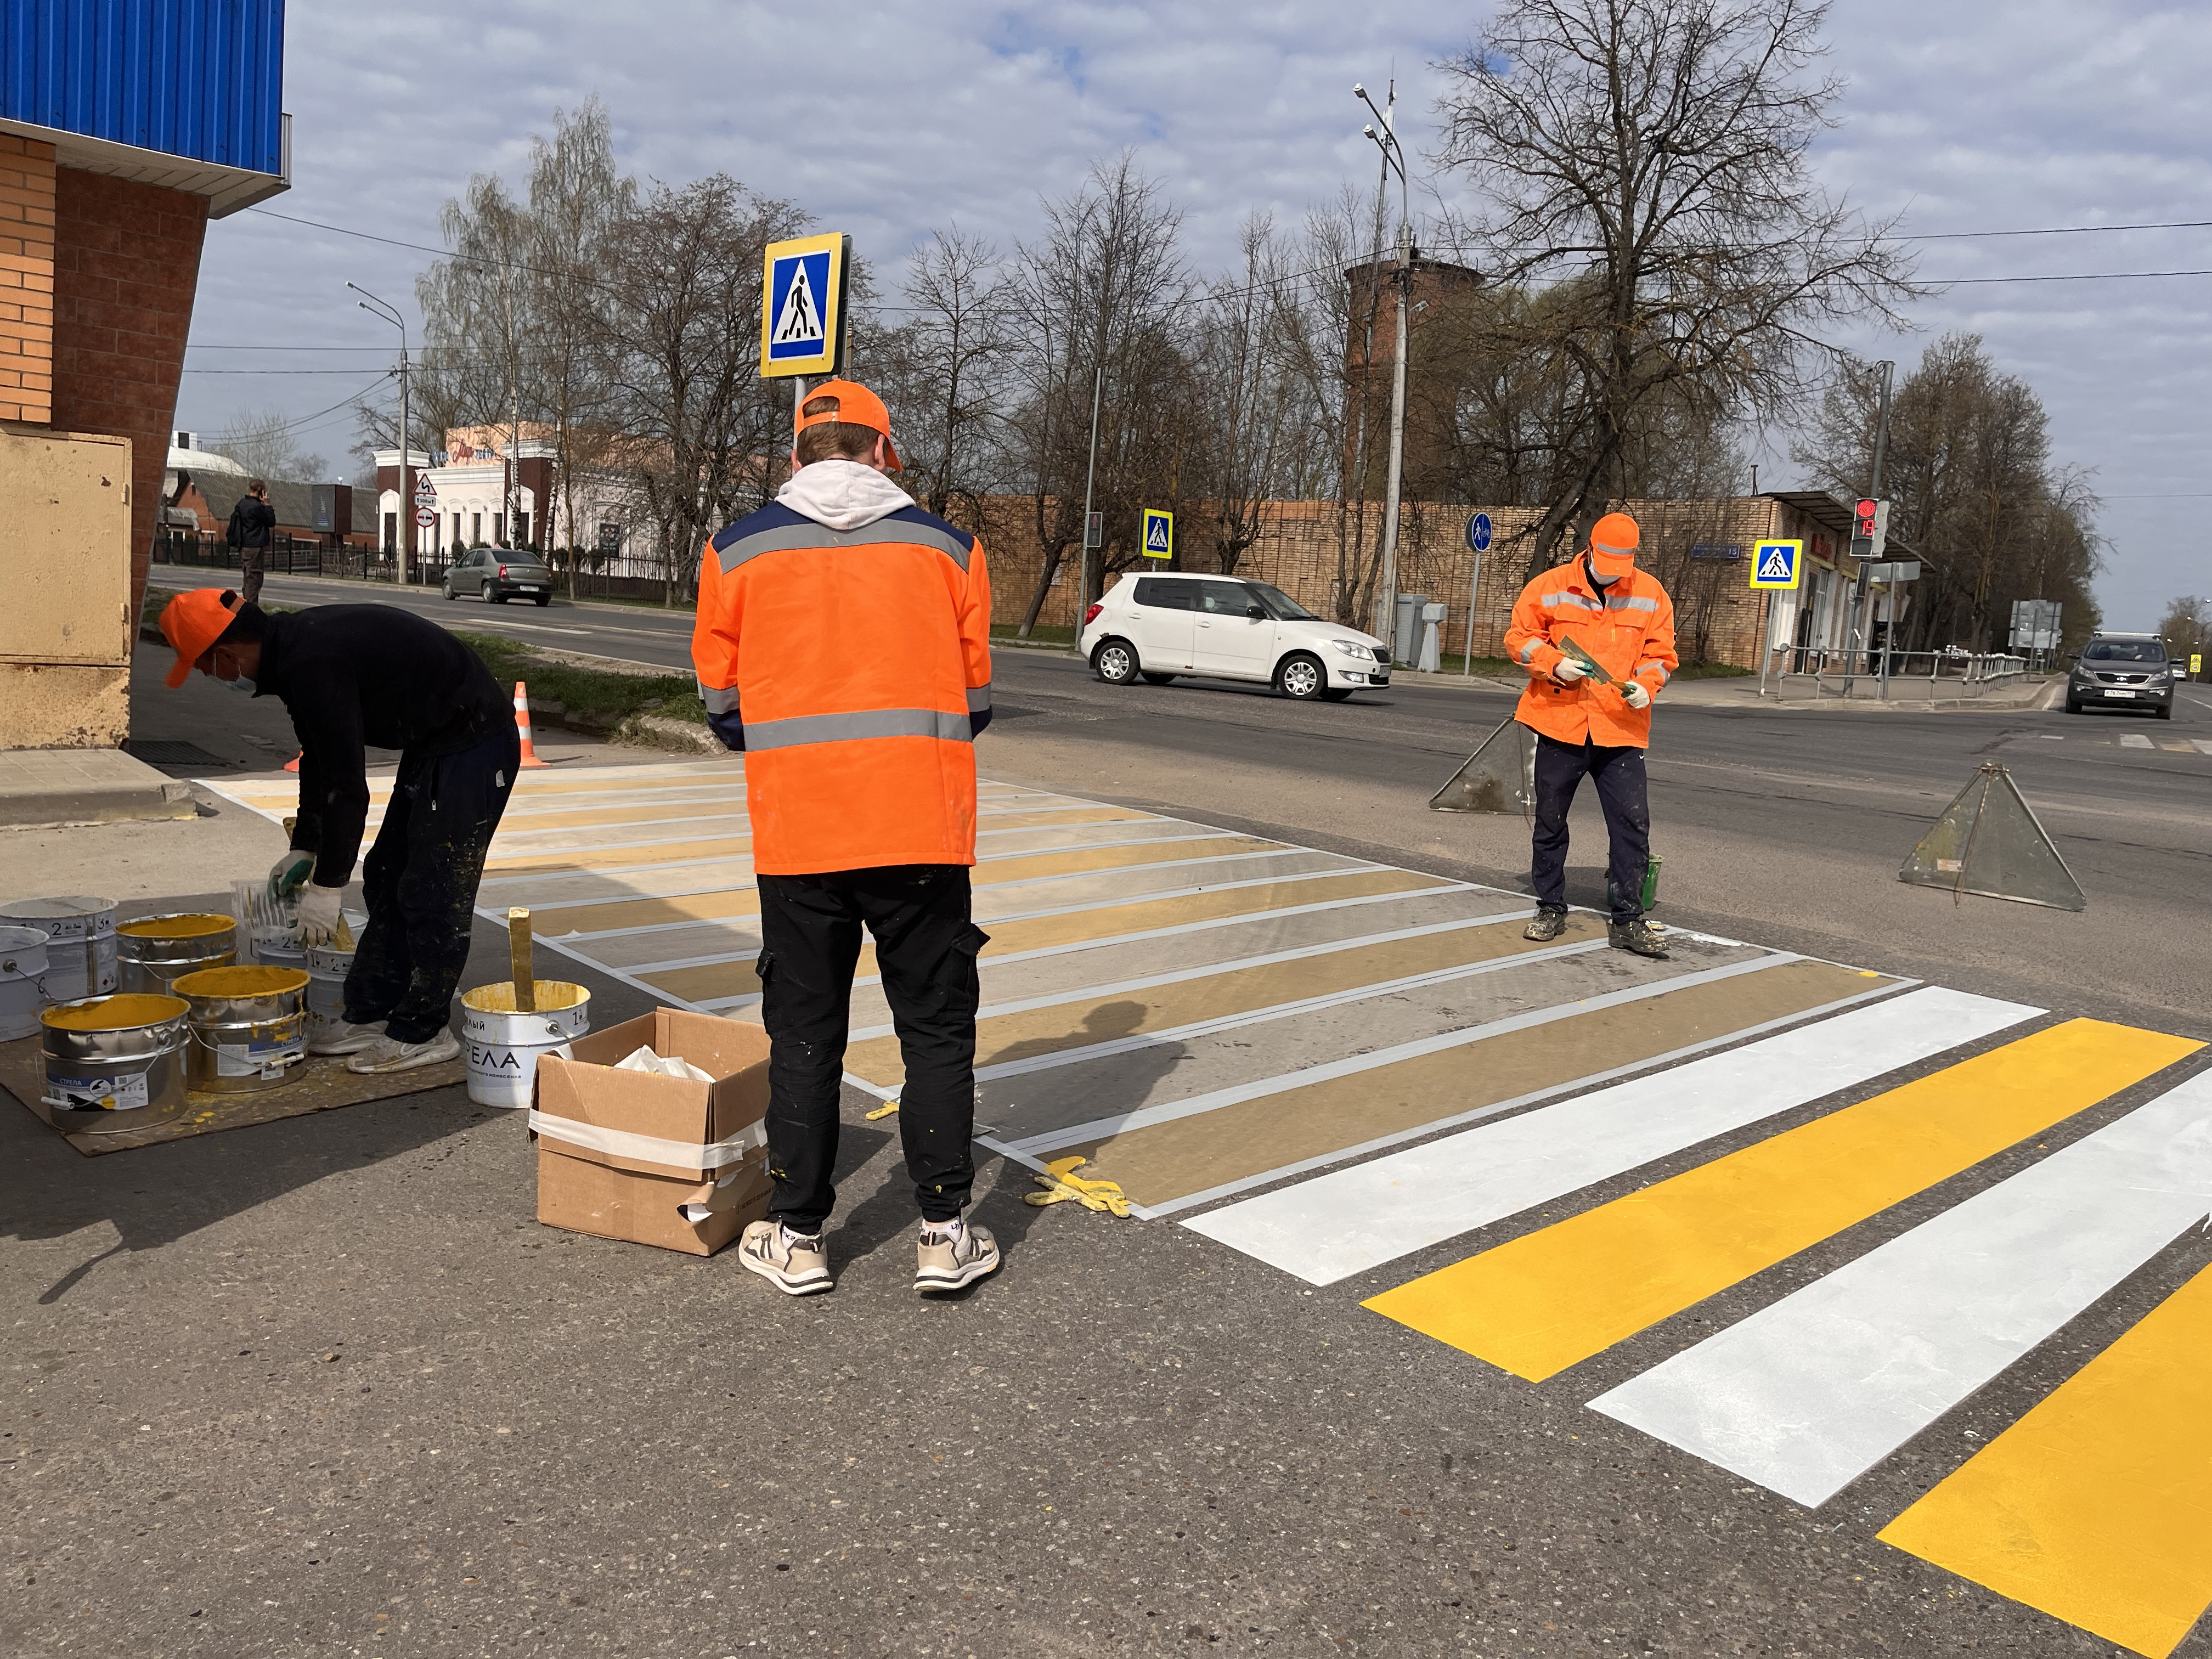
[1506,513,1681,958]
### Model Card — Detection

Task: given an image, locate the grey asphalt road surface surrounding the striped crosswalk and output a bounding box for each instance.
[21,582,2212,1659]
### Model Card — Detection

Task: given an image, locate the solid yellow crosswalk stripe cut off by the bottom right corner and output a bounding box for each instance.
[1880,1267,2212,1659]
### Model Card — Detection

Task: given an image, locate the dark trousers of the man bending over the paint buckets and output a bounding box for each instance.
[345,725,522,1042]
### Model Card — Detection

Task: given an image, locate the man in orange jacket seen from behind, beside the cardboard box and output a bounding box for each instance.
[692,381,997,1296]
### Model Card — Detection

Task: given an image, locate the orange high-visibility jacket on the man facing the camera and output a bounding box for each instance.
[1506,560,1681,750]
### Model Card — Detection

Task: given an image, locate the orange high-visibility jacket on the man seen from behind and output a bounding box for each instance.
[692,502,991,876]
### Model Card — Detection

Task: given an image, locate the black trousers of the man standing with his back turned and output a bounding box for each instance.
[759,865,989,1232]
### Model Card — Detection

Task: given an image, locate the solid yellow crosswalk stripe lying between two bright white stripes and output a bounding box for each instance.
[1365,1020,2203,1383]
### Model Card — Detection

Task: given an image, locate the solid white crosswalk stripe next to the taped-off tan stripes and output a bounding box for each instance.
[1183,989,2042,1285]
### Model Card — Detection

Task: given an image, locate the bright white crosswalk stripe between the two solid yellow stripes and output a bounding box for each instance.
[1590,1073,2212,1509]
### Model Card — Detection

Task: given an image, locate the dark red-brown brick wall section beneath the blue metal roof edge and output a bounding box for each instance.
[51,166,208,624]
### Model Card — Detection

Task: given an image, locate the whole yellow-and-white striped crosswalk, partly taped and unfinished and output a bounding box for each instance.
[210,759,2212,1655]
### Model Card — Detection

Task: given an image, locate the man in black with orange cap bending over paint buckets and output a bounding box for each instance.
[161,589,520,1073]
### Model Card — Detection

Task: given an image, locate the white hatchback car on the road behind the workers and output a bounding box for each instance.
[1075,573,1389,703]
